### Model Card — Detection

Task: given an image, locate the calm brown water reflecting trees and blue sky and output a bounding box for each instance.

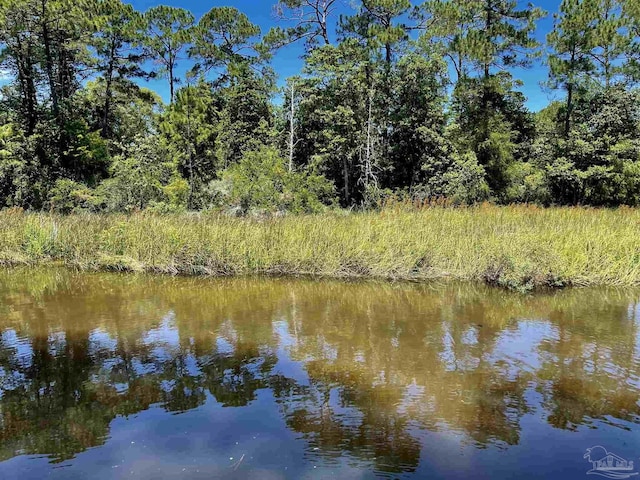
[0,270,640,480]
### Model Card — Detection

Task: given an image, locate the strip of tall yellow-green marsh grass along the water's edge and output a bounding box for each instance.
[0,206,640,290]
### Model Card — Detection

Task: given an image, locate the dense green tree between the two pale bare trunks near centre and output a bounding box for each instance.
[296,39,378,206]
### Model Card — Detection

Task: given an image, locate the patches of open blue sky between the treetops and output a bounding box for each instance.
[131,0,560,111]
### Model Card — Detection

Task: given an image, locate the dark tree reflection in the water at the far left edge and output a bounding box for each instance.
[0,330,113,459]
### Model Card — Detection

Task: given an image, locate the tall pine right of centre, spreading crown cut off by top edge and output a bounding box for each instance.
[423,0,543,198]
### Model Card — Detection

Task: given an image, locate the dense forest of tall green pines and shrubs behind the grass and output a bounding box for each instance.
[0,0,640,214]
